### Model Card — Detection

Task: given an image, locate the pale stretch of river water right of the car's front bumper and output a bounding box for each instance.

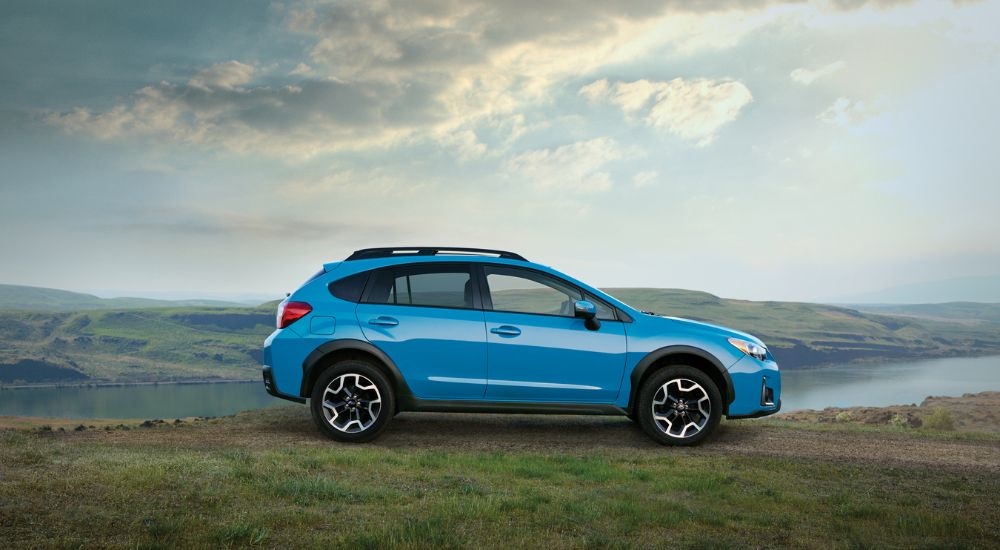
[781,356,1000,411]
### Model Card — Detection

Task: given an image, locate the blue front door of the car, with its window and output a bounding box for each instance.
[481,265,626,403]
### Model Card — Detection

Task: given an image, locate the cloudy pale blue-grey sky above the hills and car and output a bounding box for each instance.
[0,0,1000,301]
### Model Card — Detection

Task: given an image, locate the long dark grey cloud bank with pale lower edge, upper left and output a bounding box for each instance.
[46,69,424,158]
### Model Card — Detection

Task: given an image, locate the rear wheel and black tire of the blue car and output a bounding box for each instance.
[309,359,396,443]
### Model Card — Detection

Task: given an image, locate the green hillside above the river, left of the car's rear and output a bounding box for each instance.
[0,304,274,384]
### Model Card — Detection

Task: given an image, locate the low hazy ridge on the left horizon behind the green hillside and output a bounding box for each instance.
[0,284,258,311]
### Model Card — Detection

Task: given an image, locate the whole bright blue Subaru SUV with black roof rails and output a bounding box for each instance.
[264,247,781,445]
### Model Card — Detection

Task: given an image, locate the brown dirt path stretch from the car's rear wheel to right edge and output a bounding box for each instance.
[379,414,1000,472]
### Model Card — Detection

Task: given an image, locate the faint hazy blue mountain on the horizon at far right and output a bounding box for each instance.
[826,275,1000,304]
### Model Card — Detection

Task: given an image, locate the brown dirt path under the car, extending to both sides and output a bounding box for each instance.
[56,406,1000,473]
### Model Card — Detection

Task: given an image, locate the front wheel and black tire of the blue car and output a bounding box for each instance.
[638,365,722,445]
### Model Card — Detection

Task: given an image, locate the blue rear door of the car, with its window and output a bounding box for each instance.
[356,263,486,399]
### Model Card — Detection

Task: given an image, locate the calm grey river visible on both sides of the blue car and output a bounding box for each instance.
[0,356,1000,419]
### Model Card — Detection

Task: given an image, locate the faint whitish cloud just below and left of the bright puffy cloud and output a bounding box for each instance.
[507,138,626,192]
